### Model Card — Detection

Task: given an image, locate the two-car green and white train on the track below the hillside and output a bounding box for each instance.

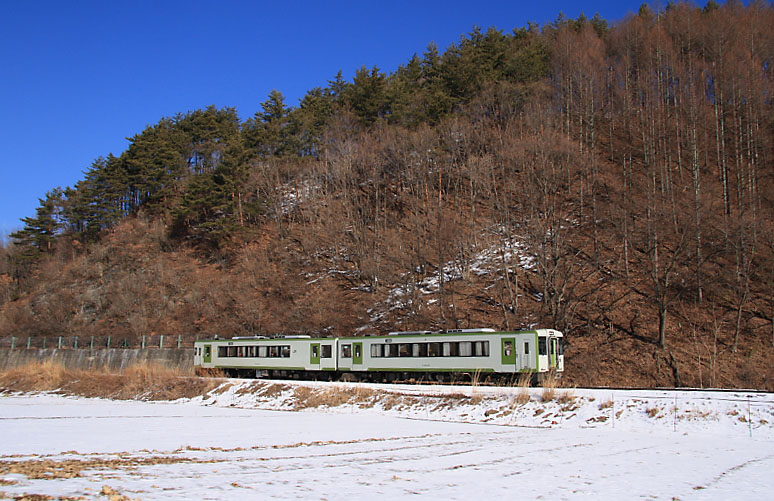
[194,328,564,382]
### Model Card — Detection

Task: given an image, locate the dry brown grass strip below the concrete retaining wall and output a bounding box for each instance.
[0,361,217,400]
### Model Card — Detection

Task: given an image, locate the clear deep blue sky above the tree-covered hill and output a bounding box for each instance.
[0,0,654,237]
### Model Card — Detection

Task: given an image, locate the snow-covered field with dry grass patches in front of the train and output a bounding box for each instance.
[0,380,774,500]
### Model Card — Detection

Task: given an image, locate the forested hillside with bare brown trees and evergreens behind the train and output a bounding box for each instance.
[0,1,774,390]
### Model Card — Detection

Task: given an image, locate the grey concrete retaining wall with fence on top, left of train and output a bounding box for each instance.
[0,348,194,372]
